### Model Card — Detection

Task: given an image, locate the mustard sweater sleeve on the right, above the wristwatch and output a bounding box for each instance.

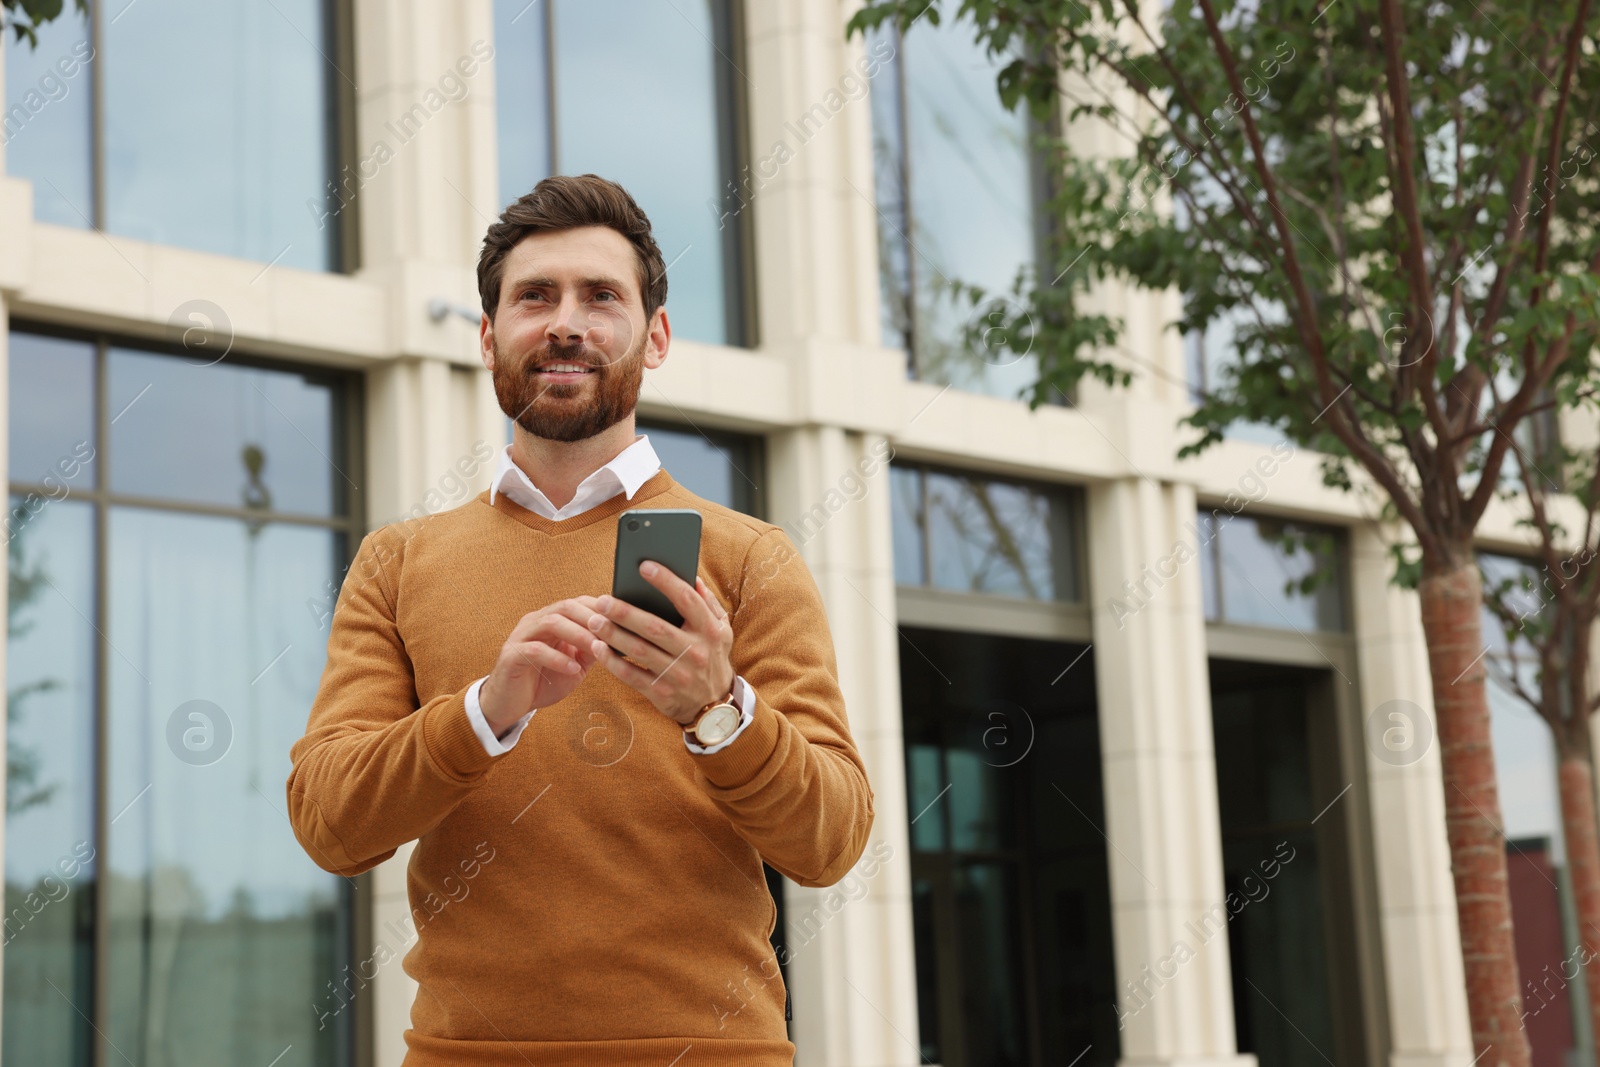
[694,528,872,886]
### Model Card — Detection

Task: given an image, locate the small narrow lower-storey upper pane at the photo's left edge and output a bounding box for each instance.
[8,331,96,496]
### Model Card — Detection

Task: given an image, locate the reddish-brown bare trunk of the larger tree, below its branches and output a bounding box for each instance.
[1418,563,1530,1067]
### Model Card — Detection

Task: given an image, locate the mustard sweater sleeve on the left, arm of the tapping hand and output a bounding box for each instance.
[286,530,499,877]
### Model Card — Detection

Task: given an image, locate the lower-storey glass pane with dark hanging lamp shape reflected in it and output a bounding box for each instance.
[107,349,350,515]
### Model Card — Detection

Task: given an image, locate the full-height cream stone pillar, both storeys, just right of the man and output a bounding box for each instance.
[741,0,920,1067]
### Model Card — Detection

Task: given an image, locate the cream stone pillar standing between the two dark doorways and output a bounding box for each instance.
[1088,477,1254,1067]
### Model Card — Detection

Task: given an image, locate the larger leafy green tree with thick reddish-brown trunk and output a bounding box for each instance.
[850,0,1600,1067]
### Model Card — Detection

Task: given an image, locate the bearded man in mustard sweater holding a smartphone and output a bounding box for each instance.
[288,174,872,1067]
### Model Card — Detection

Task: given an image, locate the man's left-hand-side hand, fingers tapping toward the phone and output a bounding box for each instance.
[478,597,598,737]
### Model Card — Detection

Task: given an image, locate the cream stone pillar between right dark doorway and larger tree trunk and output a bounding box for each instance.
[1350,523,1472,1067]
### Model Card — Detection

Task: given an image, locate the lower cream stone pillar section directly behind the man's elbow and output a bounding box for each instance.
[768,426,922,1067]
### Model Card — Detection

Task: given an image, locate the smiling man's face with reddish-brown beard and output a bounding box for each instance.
[480,226,670,442]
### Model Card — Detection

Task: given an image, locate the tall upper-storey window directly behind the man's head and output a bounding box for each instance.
[494,0,752,344]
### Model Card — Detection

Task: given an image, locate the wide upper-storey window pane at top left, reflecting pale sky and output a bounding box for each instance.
[98,0,334,270]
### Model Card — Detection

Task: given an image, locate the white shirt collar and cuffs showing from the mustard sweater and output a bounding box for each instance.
[467,434,755,755]
